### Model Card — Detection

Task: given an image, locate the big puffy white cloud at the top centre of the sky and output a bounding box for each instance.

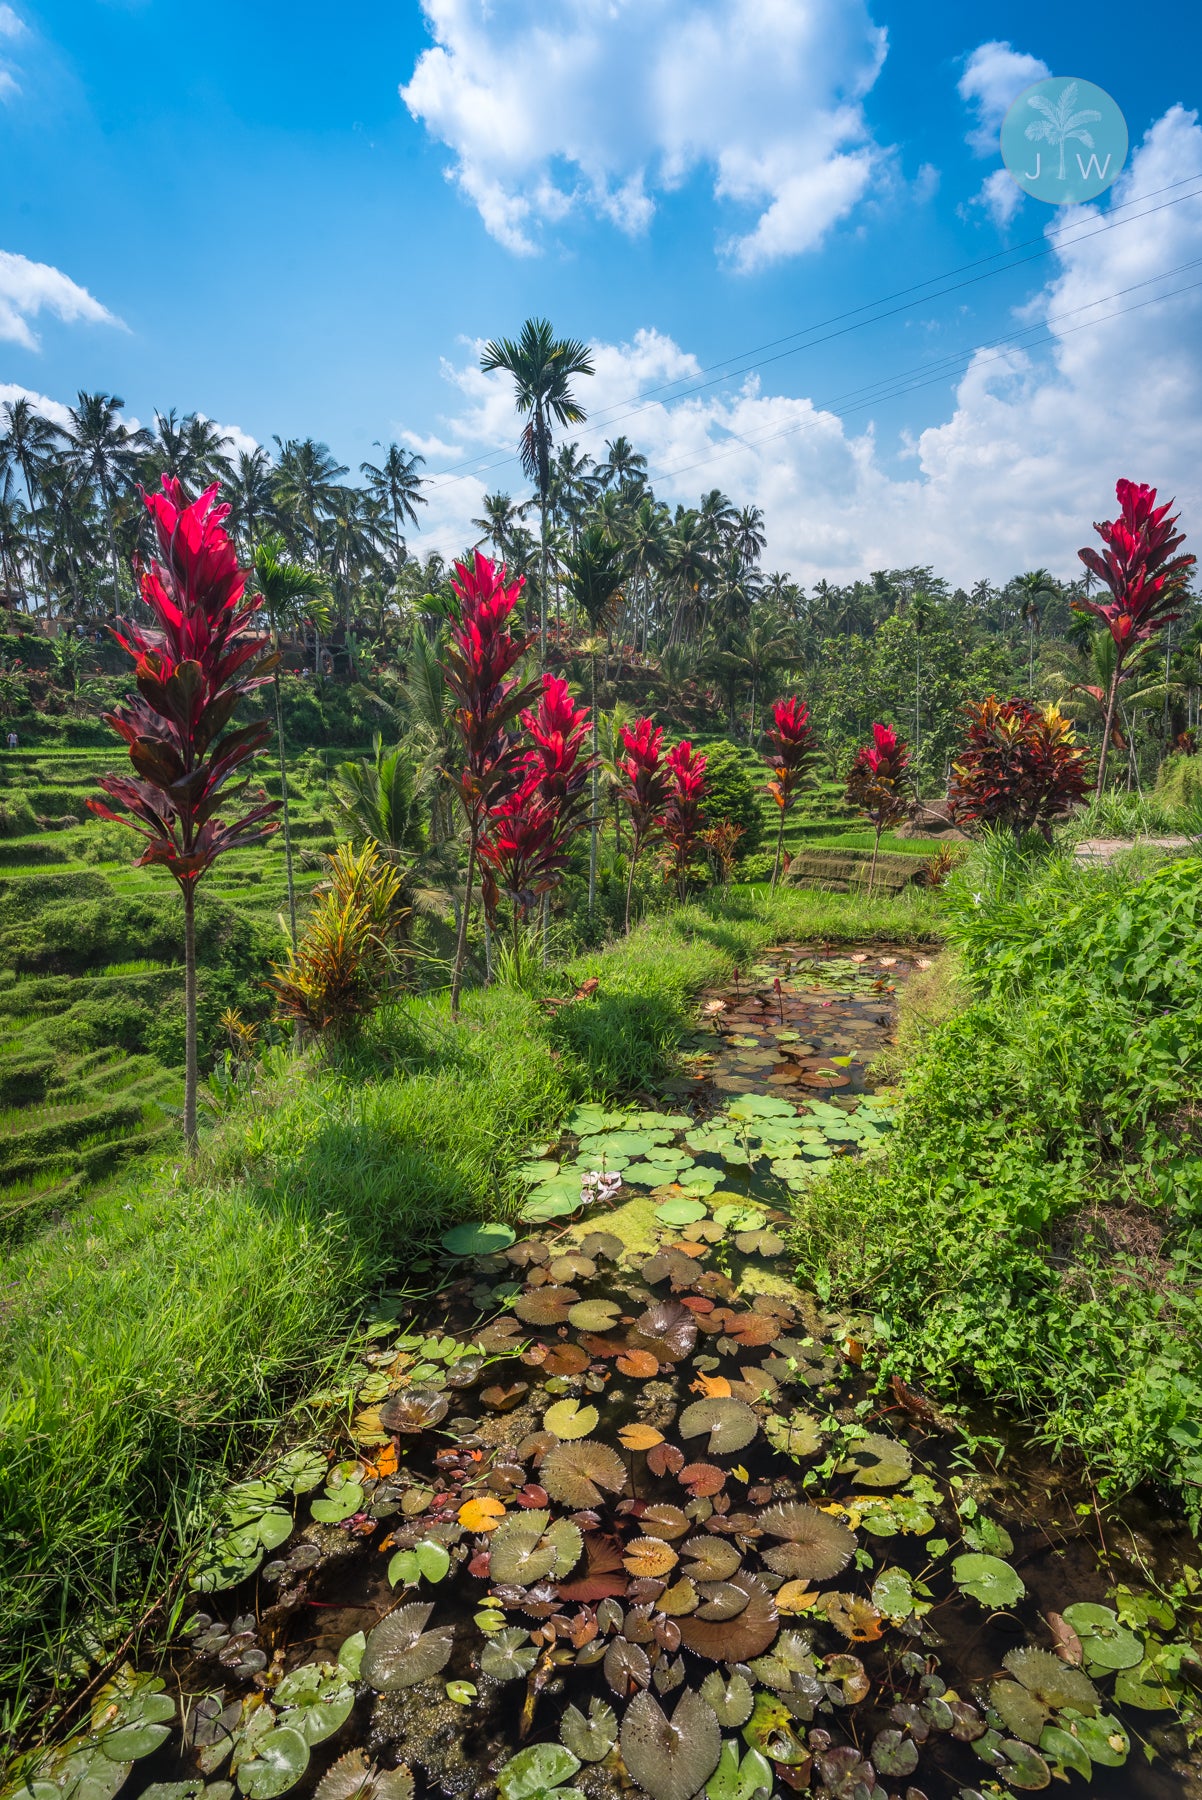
[401,0,885,270]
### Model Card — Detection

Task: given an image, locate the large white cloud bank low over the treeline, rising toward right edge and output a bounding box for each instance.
[416,106,1202,585]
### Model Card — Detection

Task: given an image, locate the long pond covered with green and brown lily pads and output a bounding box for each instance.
[16,945,1198,1800]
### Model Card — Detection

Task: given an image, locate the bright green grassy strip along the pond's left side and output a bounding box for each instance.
[0,891,928,1717]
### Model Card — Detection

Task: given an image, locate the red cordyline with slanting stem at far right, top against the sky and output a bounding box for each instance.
[1072,481,1197,796]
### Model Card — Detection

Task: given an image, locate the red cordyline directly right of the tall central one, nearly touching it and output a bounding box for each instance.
[477,675,592,961]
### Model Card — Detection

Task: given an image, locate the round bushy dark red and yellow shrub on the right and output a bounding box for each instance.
[948,695,1087,841]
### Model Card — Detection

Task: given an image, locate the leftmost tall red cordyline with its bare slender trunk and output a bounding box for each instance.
[88,475,279,1152]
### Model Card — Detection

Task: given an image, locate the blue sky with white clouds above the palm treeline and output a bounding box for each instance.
[0,0,1202,580]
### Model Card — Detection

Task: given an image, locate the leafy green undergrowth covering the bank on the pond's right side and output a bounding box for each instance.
[797,851,1202,1521]
